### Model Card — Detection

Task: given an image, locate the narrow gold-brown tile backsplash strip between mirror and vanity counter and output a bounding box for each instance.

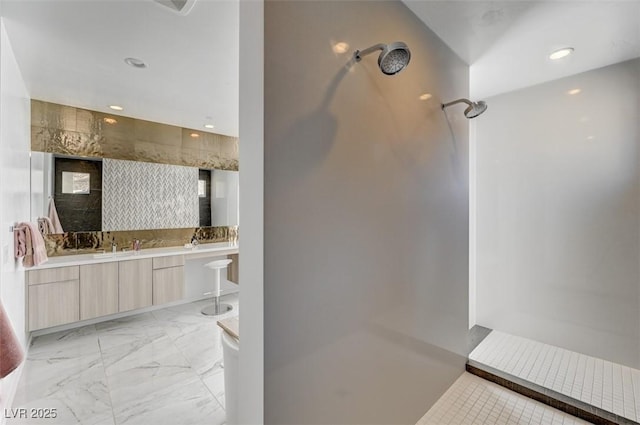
[44,226,238,257]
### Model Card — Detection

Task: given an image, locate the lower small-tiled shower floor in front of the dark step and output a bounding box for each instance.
[416,372,589,425]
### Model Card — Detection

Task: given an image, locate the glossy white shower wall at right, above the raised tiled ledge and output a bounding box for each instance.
[476,60,640,368]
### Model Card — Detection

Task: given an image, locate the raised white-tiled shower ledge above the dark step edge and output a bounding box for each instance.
[469,331,640,422]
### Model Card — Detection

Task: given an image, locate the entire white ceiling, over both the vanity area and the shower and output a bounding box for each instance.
[0,0,640,136]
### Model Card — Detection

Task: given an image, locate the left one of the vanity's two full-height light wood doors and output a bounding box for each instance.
[80,263,118,320]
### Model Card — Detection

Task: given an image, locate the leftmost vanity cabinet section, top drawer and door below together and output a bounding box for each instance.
[27,266,80,331]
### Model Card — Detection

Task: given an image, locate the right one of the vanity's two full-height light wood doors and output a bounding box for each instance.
[118,258,153,311]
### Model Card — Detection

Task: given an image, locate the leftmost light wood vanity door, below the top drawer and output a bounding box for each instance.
[28,279,80,331]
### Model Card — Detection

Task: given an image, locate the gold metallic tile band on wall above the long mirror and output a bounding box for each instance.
[31,100,238,170]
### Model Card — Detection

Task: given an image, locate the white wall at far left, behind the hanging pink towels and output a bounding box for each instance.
[0,18,31,416]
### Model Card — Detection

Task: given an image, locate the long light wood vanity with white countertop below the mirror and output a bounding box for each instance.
[27,243,238,331]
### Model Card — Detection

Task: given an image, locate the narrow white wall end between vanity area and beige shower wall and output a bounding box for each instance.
[238,0,264,424]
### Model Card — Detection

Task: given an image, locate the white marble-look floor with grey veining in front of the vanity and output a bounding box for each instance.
[7,294,239,425]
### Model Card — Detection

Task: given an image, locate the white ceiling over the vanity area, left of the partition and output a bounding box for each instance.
[2,0,239,136]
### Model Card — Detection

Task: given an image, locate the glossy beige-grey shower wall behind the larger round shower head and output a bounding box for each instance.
[264,0,469,424]
